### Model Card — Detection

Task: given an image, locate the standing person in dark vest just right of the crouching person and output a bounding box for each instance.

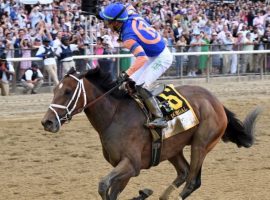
[36,38,59,86]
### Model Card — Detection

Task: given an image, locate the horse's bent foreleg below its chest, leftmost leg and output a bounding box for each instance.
[98,158,135,200]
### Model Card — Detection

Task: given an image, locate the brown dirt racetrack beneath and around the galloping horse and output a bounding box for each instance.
[0,80,270,200]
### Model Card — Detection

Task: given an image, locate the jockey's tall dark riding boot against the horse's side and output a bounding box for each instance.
[136,86,168,128]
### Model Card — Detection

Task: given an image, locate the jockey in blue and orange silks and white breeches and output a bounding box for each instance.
[99,3,173,128]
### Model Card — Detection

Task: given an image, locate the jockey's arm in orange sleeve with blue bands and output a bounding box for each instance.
[123,39,148,76]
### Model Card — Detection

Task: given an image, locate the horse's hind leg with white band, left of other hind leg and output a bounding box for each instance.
[159,150,189,200]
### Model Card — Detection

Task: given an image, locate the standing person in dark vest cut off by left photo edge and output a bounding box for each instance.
[0,53,15,96]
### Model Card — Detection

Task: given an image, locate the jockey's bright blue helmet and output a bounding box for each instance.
[99,3,128,22]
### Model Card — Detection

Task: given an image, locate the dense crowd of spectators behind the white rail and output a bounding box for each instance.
[0,0,270,86]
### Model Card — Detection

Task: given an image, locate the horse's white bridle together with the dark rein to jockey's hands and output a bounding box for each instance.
[49,74,122,126]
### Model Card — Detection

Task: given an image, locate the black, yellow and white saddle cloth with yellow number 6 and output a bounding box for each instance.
[155,84,199,139]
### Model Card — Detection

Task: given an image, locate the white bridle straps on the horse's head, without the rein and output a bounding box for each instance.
[49,74,87,126]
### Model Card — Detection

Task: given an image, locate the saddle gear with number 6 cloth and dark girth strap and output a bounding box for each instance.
[132,84,199,166]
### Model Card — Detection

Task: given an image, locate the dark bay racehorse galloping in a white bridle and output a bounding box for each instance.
[42,70,260,200]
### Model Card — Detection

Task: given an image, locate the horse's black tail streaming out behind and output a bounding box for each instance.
[222,107,262,148]
